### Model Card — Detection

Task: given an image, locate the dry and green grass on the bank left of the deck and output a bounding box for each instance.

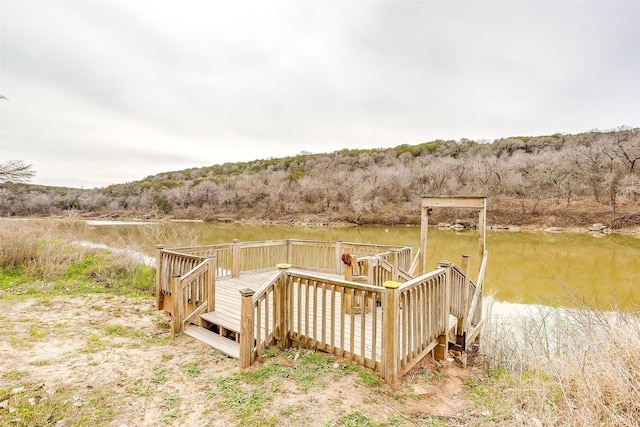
[0,218,154,296]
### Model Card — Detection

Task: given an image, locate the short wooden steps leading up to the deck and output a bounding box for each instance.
[184,311,240,359]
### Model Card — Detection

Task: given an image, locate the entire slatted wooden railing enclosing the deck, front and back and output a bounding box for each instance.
[157,240,487,384]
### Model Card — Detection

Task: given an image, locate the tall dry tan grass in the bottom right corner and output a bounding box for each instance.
[470,298,640,426]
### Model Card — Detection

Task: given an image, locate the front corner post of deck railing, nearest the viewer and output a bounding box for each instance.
[382,281,400,386]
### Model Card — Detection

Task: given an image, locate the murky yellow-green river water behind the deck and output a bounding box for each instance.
[79,223,640,310]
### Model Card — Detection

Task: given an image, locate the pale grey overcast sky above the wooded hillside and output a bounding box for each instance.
[0,0,640,188]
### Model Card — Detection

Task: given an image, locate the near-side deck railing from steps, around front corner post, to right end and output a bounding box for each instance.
[240,262,478,384]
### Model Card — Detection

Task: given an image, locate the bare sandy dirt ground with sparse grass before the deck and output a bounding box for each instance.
[0,295,477,427]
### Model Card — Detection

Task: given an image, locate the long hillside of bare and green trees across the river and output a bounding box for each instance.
[0,128,640,227]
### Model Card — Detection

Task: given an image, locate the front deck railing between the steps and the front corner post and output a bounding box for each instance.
[240,267,385,371]
